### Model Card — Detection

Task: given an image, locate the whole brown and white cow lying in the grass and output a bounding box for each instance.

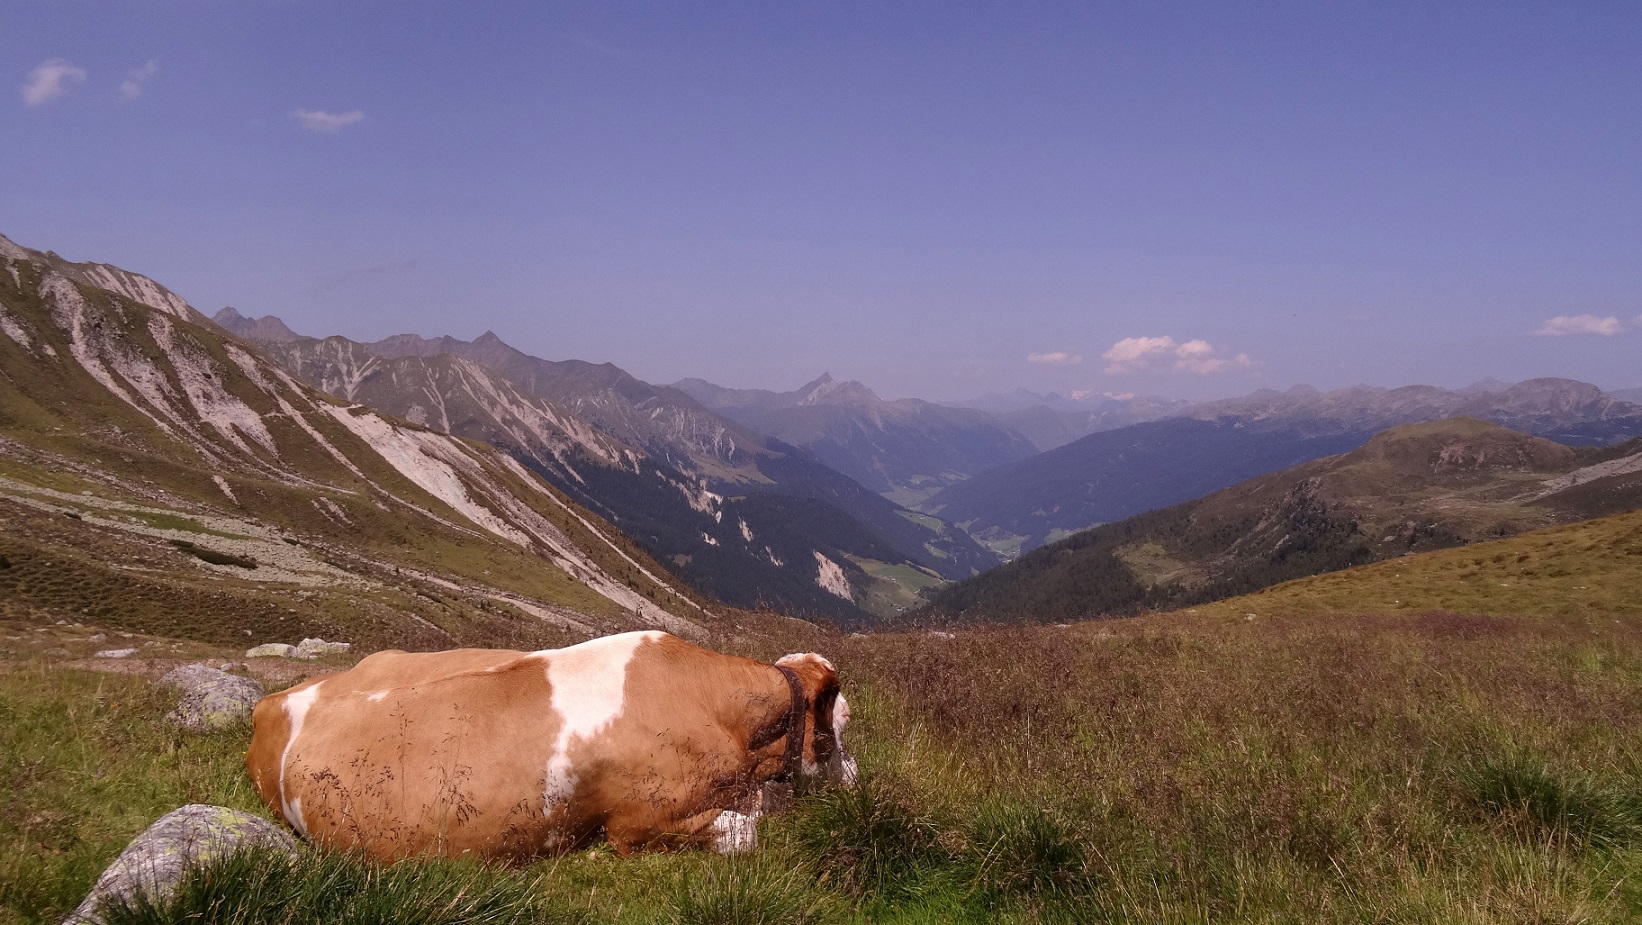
[246,631,855,861]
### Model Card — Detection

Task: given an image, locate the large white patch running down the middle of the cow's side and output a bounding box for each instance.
[535,629,663,813]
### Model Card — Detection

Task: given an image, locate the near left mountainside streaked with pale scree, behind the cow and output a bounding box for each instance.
[0,231,724,646]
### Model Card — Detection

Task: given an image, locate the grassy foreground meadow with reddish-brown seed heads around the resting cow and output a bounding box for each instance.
[9,514,1642,923]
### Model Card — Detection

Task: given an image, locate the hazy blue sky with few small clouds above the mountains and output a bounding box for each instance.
[0,0,1642,398]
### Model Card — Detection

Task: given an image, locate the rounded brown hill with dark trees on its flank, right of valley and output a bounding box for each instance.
[921,419,1642,621]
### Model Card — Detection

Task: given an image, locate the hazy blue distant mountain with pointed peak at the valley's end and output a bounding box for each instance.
[673,375,1036,504]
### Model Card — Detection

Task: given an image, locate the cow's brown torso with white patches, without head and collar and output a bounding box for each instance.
[248,633,726,859]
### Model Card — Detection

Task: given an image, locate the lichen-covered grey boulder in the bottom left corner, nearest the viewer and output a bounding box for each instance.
[62,803,297,925]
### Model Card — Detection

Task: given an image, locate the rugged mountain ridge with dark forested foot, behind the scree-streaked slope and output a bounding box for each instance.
[222,322,997,626]
